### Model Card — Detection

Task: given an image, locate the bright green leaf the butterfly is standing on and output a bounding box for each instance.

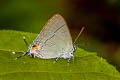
[0,30,120,80]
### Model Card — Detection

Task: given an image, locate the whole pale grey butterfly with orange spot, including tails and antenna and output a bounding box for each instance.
[13,14,84,63]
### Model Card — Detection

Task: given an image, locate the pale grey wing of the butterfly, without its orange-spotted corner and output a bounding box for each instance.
[34,14,73,59]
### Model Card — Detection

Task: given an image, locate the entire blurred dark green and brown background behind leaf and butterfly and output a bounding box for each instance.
[0,0,120,70]
